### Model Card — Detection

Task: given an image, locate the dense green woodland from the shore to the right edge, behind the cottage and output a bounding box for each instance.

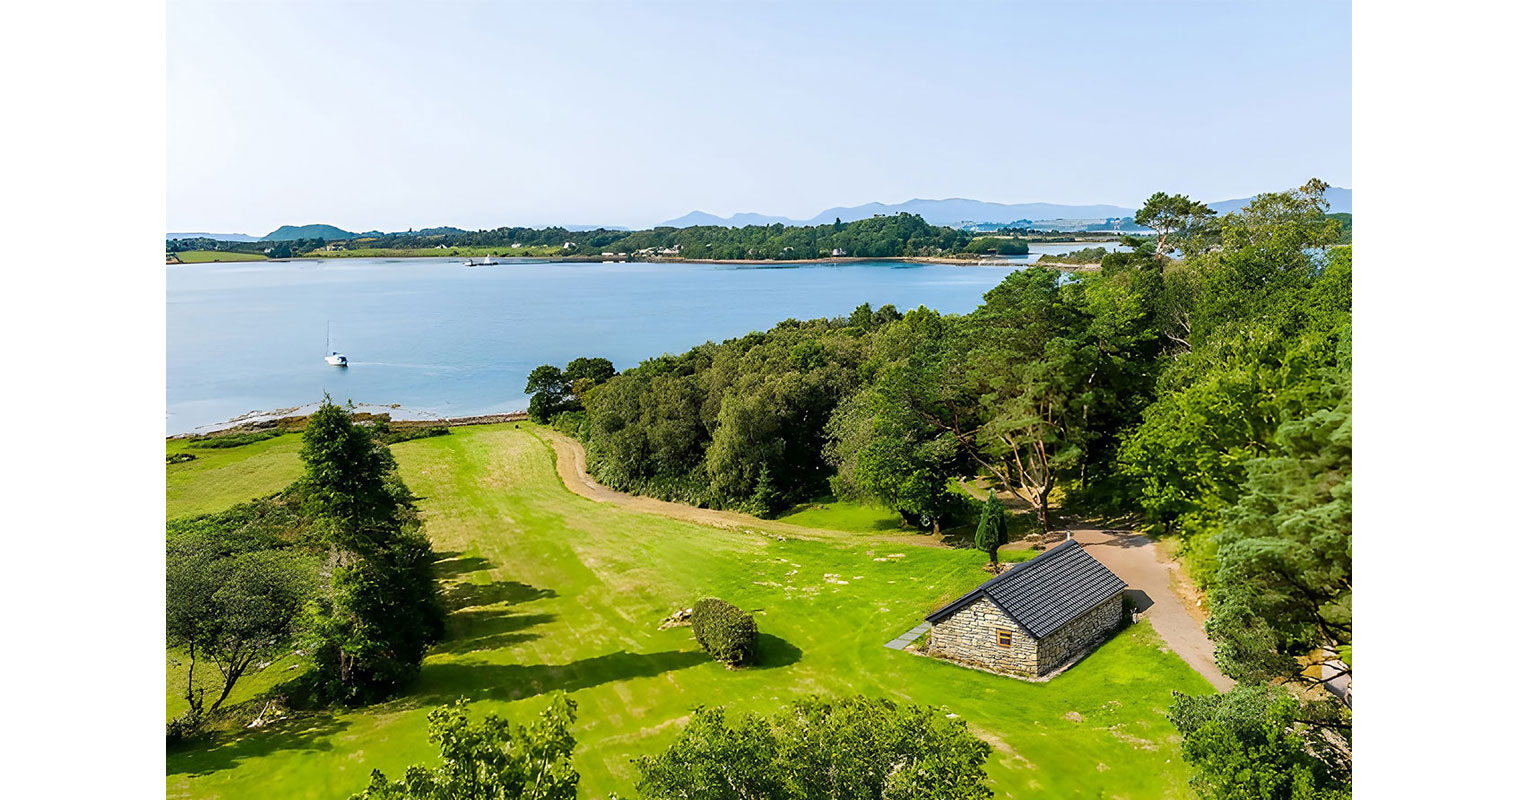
[547,181,1351,797]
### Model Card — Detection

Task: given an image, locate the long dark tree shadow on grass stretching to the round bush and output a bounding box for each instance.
[403,649,711,707]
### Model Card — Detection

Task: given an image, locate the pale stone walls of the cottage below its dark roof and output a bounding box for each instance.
[929,593,1125,678]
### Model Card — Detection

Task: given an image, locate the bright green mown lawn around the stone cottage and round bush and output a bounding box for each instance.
[167,424,1210,800]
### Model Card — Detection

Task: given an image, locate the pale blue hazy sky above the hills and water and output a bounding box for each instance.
[167,0,1351,234]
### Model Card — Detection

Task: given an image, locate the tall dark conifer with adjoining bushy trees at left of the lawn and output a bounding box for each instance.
[166,402,444,733]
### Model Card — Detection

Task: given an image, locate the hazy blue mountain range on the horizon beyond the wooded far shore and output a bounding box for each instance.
[658,187,1351,228]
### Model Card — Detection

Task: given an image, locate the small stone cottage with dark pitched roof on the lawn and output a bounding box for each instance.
[924,540,1125,678]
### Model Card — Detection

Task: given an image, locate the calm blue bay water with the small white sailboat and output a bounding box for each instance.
[166,245,1113,433]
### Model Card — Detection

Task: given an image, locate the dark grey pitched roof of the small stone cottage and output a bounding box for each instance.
[924,540,1125,639]
